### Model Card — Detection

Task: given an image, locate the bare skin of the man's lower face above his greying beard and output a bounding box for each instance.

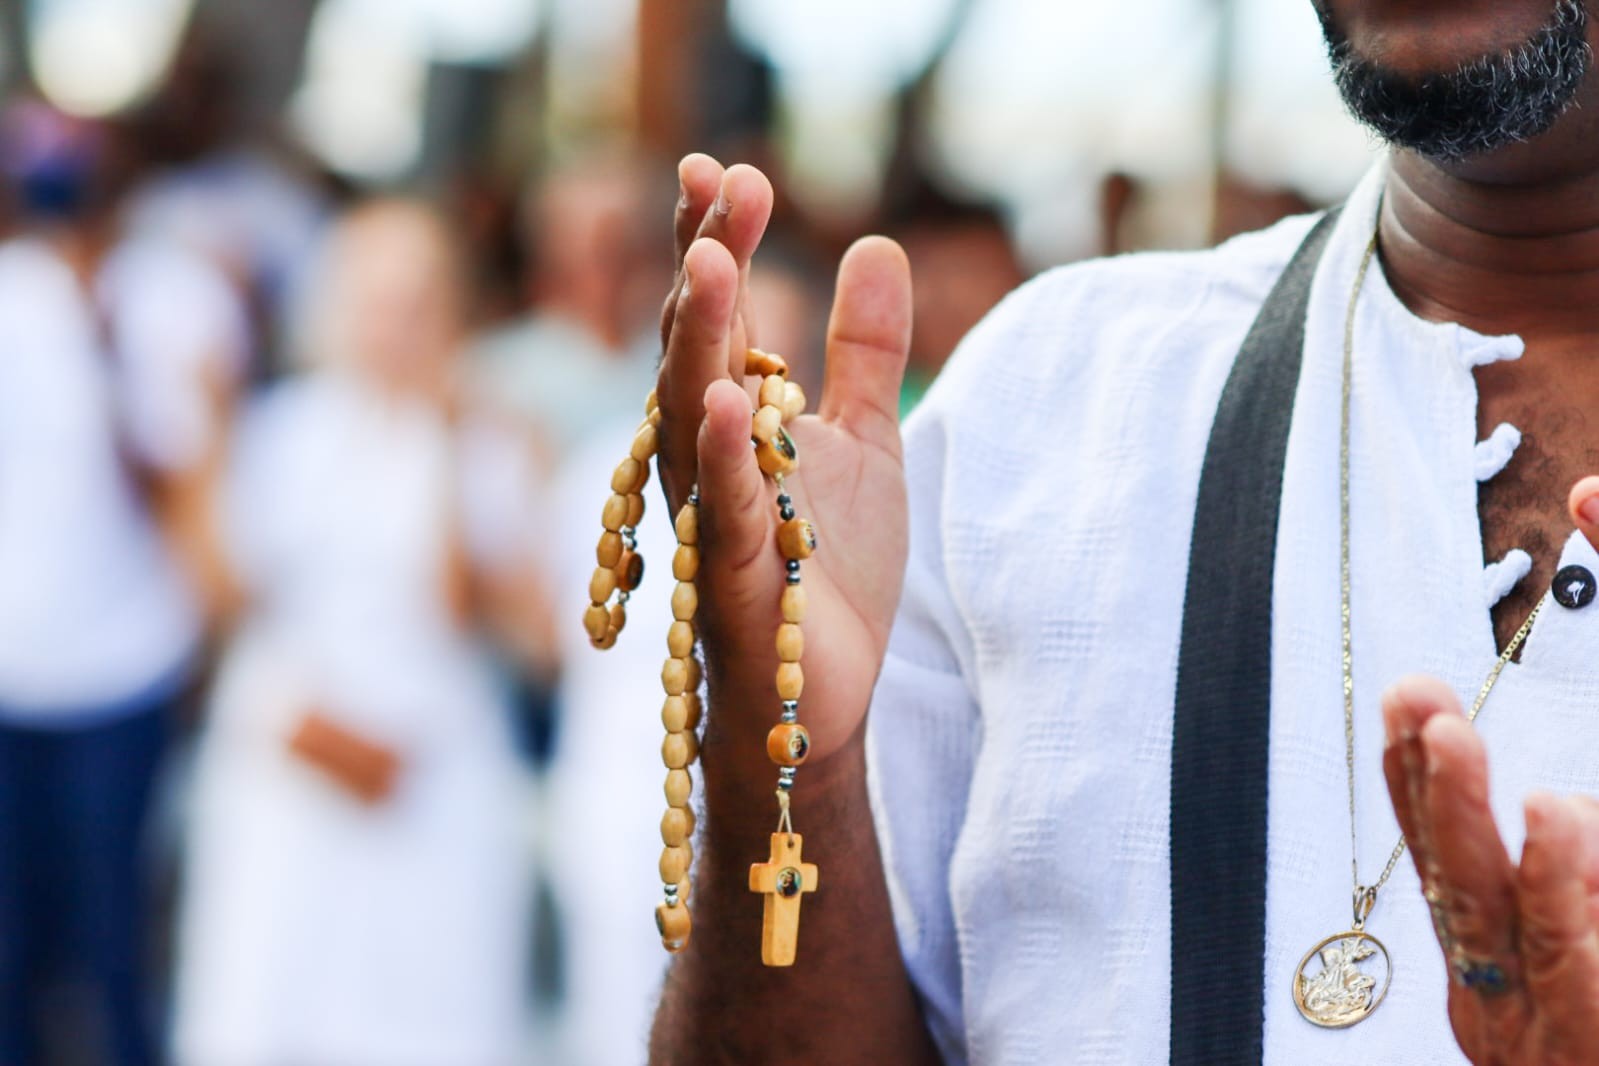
[1311,0,1556,80]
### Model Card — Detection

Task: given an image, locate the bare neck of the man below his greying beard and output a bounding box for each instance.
[1378,66,1599,342]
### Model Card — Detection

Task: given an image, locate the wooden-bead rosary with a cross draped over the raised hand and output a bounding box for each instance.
[584,348,817,965]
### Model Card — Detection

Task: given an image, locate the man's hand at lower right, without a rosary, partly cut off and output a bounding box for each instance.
[1383,478,1599,1066]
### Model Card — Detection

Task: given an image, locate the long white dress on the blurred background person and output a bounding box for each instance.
[176,374,529,1066]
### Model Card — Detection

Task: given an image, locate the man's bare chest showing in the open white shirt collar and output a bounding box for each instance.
[1477,352,1599,647]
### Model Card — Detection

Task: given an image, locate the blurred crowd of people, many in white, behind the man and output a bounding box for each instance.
[0,5,1375,1066]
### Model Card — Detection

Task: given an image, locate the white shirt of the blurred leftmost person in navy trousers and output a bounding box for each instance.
[0,240,245,715]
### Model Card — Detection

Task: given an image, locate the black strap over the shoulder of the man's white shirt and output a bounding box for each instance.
[1172,211,1338,1066]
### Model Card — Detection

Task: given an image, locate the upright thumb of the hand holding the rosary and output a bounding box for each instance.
[817,237,911,455]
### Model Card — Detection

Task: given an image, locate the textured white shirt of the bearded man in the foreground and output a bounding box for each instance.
[870,166,1599,1066]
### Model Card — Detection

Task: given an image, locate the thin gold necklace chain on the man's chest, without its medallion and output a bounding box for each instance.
[1338,235,1543,930]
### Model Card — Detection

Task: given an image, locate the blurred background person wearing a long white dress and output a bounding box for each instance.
[174,201,552,1066]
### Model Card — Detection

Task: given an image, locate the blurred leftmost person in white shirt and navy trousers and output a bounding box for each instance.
[0,102,246,1066]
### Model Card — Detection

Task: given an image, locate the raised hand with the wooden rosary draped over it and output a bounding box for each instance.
[659,155,911,777]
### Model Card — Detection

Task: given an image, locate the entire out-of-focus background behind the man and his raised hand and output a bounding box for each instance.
[0,0,1377,1066]
